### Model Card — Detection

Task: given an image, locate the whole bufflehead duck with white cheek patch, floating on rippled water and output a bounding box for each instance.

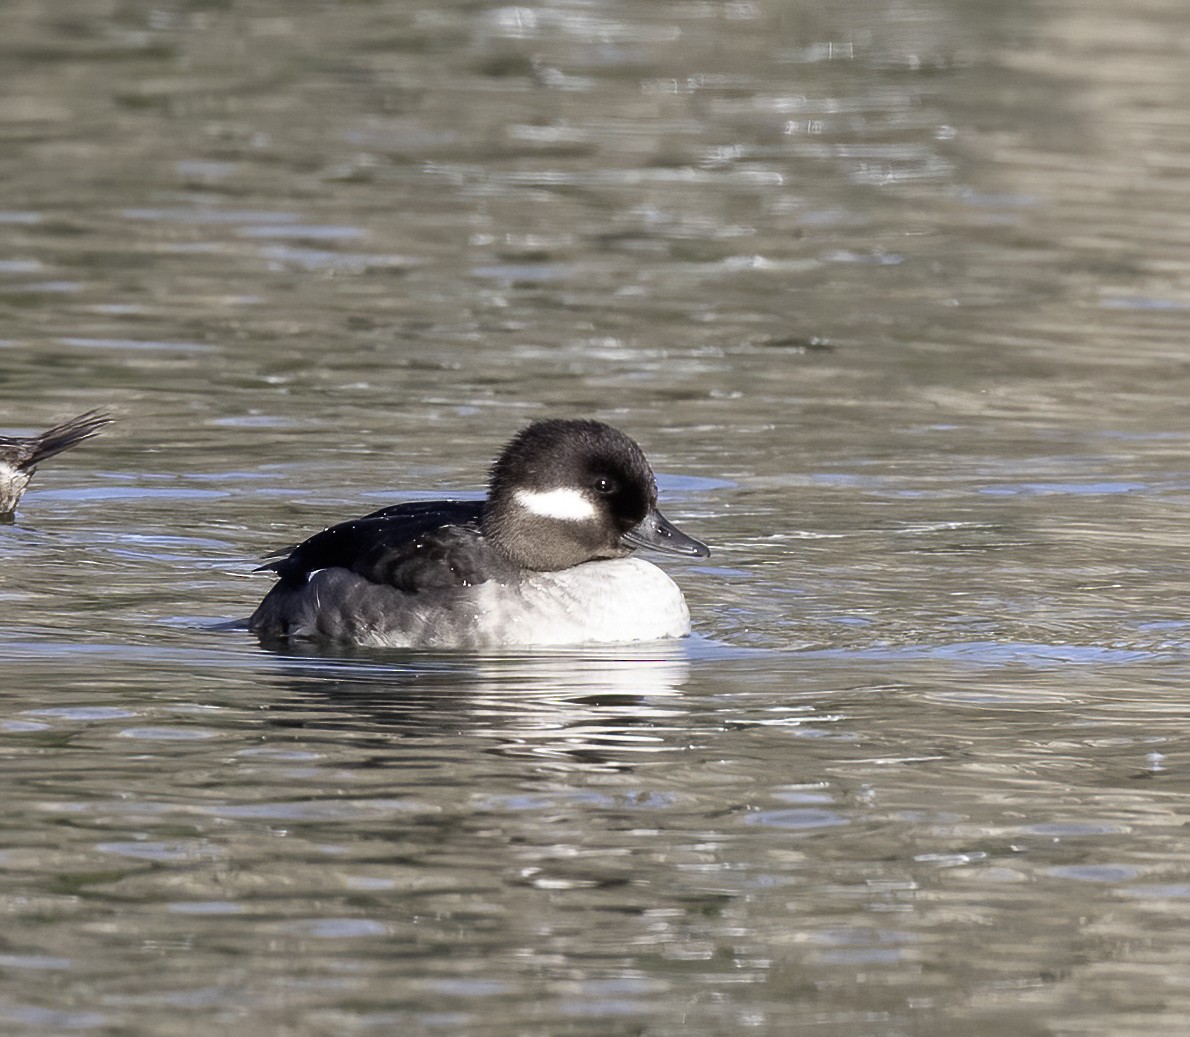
[249,419,710,649]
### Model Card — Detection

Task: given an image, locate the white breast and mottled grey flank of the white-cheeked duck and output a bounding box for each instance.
[259,558,690,649]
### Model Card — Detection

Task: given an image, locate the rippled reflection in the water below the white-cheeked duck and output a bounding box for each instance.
[255,642,689,767]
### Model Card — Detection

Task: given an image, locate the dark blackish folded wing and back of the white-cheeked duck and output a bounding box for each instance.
[261,500,511,593]
